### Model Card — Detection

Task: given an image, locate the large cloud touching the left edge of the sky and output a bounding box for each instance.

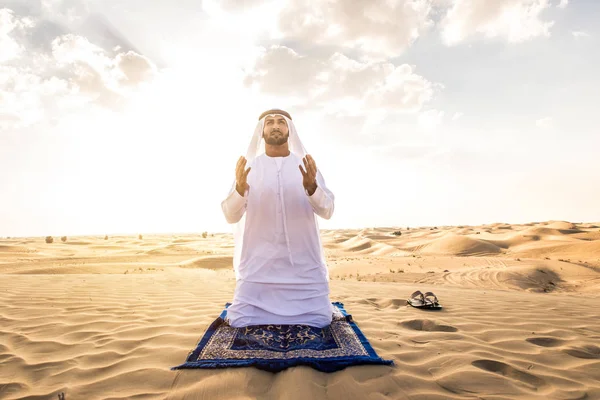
[0,7,157,129]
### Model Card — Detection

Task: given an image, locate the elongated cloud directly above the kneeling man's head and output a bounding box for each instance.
[245,46,442,115]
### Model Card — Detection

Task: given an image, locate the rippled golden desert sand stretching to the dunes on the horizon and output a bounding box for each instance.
[0,221,600,400]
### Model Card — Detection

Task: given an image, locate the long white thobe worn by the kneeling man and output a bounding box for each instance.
[221,153,334,327]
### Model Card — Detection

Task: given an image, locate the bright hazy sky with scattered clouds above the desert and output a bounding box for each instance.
[0,0,600,237]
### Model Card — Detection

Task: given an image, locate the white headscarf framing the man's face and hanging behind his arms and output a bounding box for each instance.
[228,113,324,278]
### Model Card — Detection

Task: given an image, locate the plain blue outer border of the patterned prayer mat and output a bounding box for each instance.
[171,302,394,372]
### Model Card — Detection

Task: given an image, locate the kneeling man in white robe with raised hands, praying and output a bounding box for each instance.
[221,110,334,328]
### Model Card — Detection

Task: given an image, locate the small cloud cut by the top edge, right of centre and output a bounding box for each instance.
[440,0,554,45]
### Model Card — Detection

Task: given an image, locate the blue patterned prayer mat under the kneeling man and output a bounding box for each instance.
[171,302,394,372]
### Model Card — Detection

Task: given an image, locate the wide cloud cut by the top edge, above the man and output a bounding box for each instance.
[203,0,434,60]
